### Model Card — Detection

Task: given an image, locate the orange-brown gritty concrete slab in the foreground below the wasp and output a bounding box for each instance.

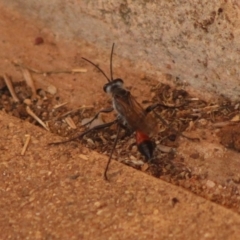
[0,112,240,240]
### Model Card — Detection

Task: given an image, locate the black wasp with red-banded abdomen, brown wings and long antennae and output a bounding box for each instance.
[49,44,158,180]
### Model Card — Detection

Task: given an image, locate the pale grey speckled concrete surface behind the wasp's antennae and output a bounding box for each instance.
[3,0,240,100]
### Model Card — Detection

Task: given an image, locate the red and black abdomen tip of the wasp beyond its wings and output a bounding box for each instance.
[136,131,155,160]
